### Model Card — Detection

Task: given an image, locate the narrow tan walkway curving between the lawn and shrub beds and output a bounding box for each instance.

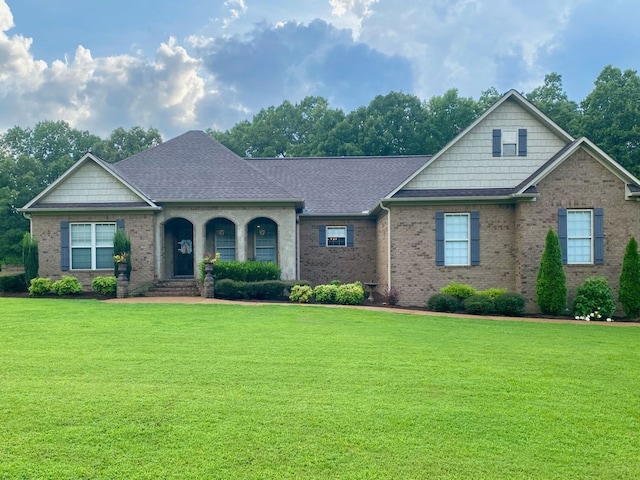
[104,297,640,327]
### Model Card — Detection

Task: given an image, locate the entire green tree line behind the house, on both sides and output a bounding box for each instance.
[0,65,640,264]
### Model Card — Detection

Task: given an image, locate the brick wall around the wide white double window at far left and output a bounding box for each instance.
[32,213,154,290]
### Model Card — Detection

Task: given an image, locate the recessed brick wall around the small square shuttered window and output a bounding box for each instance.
[300,217,377,285]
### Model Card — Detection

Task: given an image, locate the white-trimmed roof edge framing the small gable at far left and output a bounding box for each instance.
[18,153,159,212]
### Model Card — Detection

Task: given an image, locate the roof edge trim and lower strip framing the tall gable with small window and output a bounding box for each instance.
[387,90,574,198]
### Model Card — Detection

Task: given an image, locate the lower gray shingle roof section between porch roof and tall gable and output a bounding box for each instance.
[247,155,431,215]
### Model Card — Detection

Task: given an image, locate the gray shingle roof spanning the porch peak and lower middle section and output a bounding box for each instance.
[110,131,431,215]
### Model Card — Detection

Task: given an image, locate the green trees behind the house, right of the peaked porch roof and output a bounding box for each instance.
[208,65,640,179]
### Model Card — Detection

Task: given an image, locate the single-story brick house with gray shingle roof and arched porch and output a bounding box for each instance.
[21,90,640,311]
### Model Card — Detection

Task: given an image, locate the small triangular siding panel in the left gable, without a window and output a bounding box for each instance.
[39,162,140,204]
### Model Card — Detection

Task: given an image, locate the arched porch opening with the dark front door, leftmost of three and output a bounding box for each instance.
[164,217,194,278]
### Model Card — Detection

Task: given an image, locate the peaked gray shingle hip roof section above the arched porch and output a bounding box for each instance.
[111,131,301,202]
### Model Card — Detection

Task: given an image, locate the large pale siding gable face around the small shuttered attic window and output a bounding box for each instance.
[404,101,567,189]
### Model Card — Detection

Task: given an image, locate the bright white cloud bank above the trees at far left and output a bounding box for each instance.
[0,0,205,136]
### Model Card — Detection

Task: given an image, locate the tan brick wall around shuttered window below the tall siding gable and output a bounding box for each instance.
[391,204,515,306]
